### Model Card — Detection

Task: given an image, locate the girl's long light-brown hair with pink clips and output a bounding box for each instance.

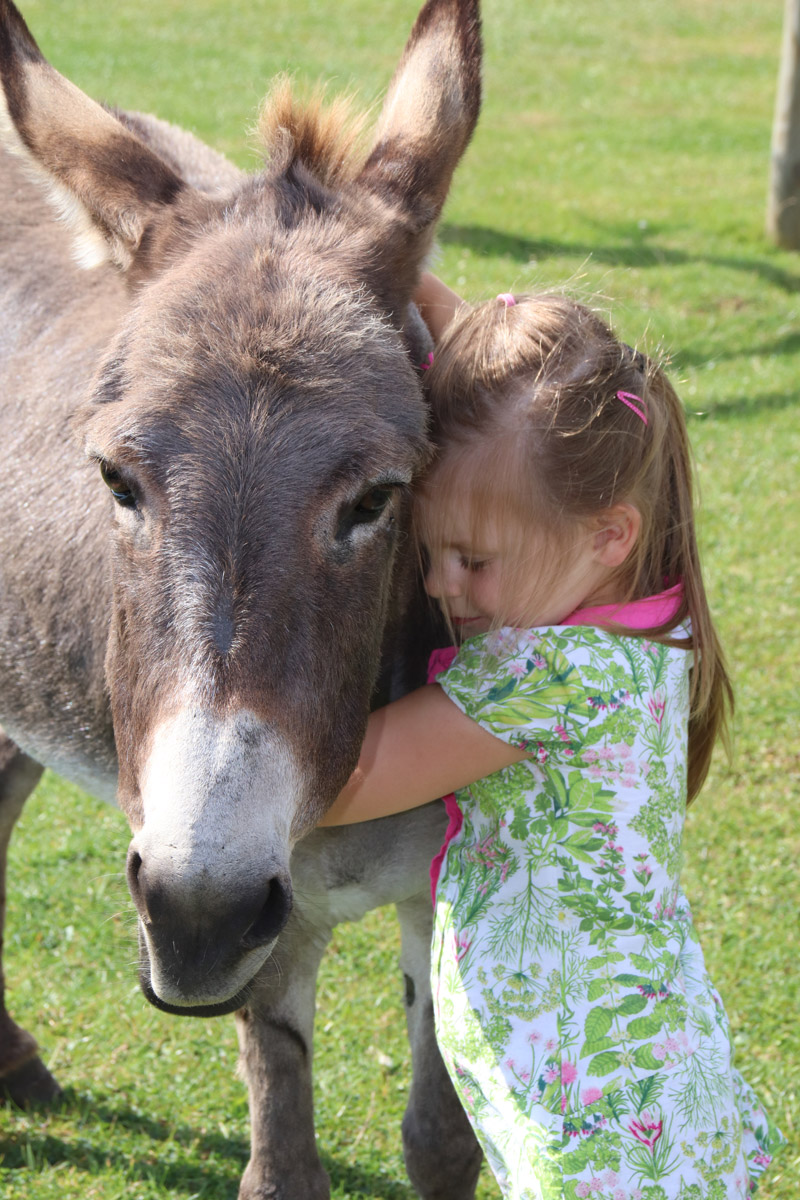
[422,295,733,802]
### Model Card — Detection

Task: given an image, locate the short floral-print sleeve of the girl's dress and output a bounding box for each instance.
[438,629,597,761]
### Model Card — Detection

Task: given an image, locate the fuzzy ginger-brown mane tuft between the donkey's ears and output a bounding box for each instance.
[255,76,367,187]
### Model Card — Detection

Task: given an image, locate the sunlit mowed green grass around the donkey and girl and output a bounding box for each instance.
[0,0,800,1200]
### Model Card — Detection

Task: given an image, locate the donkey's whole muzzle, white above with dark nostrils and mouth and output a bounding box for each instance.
[127,704,307,1010]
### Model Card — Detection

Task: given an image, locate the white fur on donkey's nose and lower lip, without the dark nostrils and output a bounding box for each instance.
[131,707,306,1007]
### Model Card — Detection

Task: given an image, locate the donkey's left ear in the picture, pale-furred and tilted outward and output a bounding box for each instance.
[0,0,186,269]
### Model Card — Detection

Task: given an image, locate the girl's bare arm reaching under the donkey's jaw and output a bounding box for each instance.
[319,684,527,826]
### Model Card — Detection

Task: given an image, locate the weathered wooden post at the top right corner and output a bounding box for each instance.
[766,0,800,250]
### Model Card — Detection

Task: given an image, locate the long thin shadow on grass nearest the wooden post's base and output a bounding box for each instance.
[438,216,800,292]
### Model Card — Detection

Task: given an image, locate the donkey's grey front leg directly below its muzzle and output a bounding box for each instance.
[236,908,330,1200]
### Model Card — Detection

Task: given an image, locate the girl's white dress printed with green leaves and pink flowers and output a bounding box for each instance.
[432,625,782,1200]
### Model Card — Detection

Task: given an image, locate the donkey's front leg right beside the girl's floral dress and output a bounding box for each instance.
[397,889,483,1200]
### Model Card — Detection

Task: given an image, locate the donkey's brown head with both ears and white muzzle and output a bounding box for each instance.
[0,0,480,1013]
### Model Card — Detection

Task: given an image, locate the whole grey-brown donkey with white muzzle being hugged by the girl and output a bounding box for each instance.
[0,0,481,1200]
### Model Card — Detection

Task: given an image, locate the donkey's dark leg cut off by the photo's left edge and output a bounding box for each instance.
[0,730,61,1108]
